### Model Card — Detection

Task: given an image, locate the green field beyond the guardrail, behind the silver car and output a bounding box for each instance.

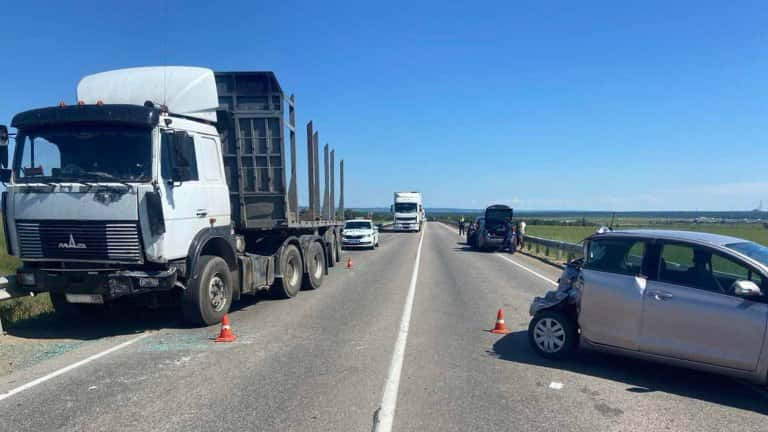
[526,222,768,245]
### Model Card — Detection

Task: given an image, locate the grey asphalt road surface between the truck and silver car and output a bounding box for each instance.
[0,223,768,431]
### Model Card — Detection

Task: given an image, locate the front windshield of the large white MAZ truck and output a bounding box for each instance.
[13,125,152,183]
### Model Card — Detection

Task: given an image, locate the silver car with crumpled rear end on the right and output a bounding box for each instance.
[528,230,768,383]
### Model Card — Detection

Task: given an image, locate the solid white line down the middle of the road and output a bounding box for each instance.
[373,224,427,432]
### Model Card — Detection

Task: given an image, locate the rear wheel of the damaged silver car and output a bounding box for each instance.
[528,310,579,360]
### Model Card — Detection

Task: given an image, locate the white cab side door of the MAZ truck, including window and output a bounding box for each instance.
[160,131,209,260]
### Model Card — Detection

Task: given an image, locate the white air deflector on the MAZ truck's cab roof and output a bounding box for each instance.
[77,66,219,122]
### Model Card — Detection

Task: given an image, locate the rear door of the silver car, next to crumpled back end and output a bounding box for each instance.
[577,237,646,350]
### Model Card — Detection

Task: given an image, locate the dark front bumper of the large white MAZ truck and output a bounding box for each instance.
[18,268,176,300]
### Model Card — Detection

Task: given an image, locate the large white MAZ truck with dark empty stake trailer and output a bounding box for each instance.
[0,67,344,325]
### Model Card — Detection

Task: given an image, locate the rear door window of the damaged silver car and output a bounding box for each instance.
[584,239,645,275]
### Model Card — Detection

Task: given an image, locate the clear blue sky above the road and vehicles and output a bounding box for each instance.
[0,0,768,211]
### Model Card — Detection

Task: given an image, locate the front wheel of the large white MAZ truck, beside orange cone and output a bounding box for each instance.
[182,255,233,326]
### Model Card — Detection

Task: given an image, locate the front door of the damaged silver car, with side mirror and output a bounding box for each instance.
[640,242,768,370]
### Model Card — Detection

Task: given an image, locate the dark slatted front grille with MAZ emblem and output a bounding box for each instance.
[16,221,142,262]
